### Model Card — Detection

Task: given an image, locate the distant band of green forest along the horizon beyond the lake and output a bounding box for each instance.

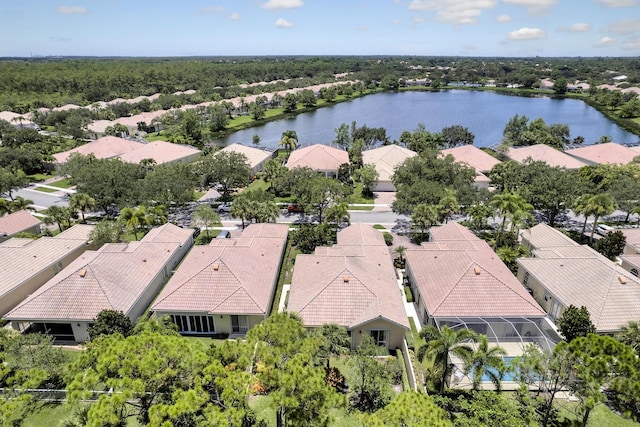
[0,56,640,114]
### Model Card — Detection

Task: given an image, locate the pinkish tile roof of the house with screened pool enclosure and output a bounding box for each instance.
[406,223,545,317]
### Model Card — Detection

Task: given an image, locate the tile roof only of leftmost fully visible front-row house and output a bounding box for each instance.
[5,224,191,321]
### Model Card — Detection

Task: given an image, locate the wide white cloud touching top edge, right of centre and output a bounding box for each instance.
[408,0,498,24]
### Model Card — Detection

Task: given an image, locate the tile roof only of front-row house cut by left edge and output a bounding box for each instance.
[0,225,94,304]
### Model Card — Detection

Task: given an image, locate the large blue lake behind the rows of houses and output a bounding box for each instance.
[218,90,640,149]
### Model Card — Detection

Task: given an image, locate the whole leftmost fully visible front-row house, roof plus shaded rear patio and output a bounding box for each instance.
[5,224,193,342]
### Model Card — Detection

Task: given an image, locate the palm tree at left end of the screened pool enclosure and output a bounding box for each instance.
[418,325,476,394]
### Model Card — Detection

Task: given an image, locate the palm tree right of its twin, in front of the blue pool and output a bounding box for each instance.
[464,335,507,391]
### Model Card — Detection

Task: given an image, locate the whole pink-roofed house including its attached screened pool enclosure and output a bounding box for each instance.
[406,222,559,356]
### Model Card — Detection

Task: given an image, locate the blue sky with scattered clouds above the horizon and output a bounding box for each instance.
[0,0,640,57]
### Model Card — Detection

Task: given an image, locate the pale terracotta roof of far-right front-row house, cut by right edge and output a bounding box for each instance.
[518,256,640,333]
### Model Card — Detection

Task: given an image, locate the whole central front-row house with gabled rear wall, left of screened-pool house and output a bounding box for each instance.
[288,223,409,349]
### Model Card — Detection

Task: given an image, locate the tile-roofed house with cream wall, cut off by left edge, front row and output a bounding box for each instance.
[0,225,94,316]
